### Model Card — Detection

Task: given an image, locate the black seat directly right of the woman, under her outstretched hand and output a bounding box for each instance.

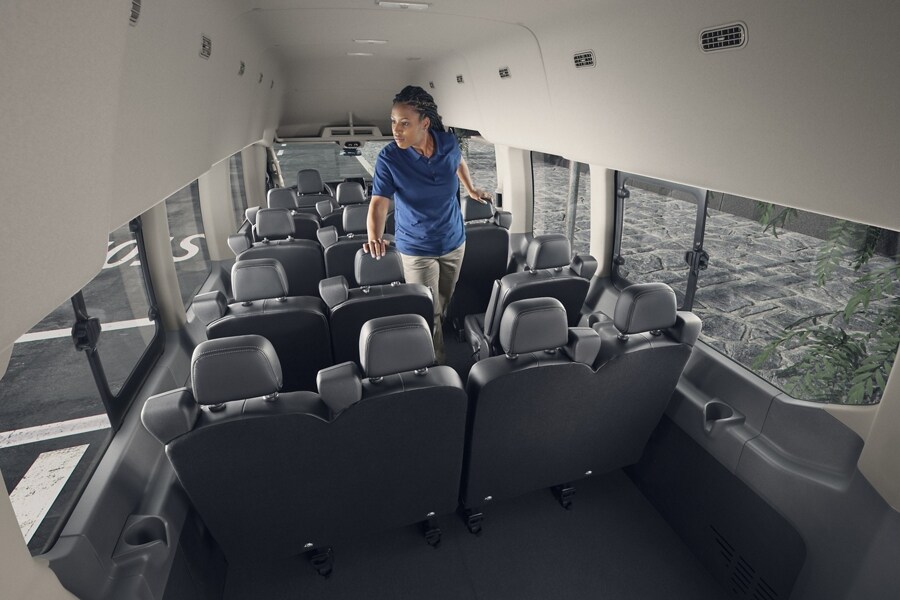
[446,198,512,332]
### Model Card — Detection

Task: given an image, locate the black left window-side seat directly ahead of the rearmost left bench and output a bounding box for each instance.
[193,258,334,391]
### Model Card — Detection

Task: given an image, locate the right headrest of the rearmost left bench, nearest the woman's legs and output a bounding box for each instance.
[359,315,434,377]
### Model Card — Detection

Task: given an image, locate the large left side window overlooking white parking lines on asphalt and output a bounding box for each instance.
[0,218,163,555]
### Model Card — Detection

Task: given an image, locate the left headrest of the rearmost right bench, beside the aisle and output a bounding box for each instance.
[500,298,569,354]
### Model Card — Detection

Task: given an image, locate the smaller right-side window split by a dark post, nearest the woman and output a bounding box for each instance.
[531,152,591,254]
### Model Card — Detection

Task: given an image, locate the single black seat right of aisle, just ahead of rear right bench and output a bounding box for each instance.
[464,233,597,360]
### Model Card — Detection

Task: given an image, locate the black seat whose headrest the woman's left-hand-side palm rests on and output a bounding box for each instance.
[319,247,434,366]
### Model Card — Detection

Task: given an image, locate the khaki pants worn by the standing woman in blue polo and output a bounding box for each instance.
[400,242,466,364]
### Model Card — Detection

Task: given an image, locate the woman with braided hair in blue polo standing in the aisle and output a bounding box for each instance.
[363,85,491,363]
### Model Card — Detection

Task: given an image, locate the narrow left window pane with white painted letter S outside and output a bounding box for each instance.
[166,181,211,307]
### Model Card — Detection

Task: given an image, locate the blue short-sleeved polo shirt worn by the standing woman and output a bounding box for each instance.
[372,131,466,256]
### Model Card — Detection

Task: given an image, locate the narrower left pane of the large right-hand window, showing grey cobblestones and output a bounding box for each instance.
[619,181,697,306]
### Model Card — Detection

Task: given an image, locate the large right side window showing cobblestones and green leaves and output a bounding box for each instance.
[617,174,900,404]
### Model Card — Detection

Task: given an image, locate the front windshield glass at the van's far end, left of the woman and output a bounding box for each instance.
[275,141,388,186]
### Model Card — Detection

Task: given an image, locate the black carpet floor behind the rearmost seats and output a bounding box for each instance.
[225,471,732,600]
